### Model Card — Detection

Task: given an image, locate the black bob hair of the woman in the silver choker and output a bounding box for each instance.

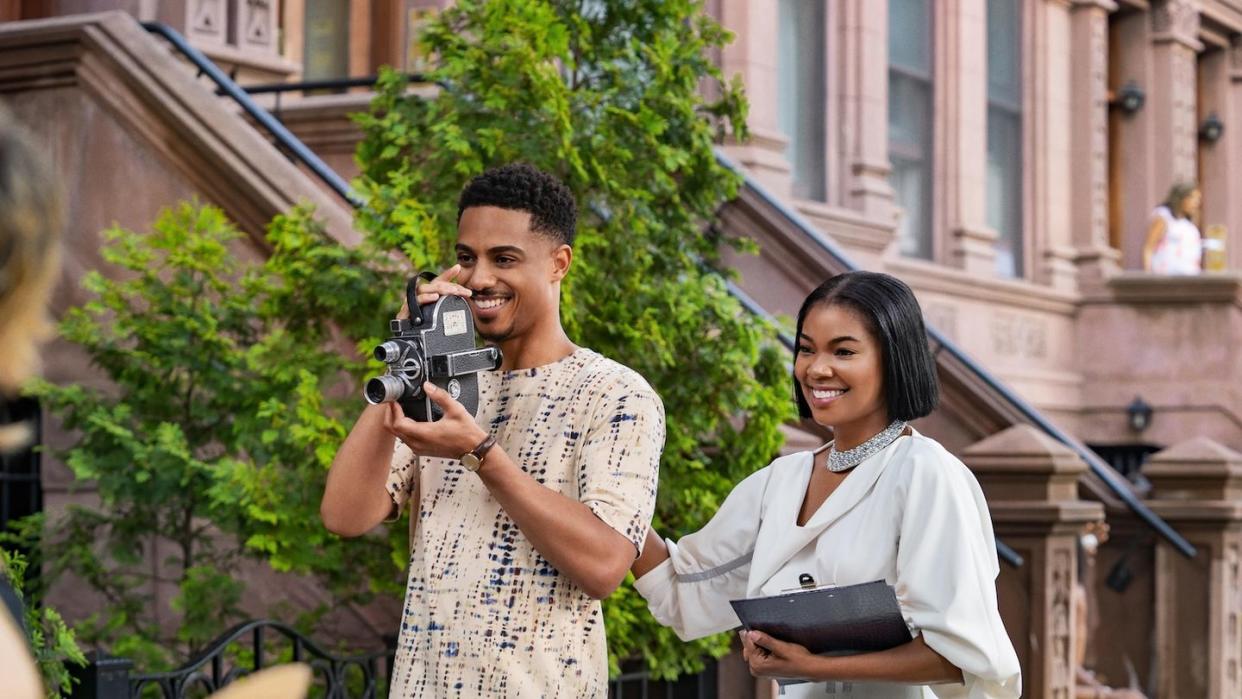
[794,272,940,421]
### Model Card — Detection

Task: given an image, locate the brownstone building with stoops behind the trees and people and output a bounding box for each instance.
[0,0,1242,698]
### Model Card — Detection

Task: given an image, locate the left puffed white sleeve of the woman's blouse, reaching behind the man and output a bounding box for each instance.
[635,467,771,641]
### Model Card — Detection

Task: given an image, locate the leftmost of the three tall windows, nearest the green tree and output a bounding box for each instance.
[776,0,827,201]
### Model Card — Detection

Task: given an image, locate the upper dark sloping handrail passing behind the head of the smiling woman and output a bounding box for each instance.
[717,150,1196,557]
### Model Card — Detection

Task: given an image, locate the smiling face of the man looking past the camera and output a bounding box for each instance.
[457,206,573,343]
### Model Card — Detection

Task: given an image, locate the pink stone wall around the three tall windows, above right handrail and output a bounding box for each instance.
[717,0,1242,459]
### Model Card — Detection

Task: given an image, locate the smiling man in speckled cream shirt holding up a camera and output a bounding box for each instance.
[320,164,664,699]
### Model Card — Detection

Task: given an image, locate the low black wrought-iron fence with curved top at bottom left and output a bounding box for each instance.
[72,620,395,699]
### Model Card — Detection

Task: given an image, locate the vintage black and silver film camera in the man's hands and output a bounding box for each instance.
[364,272,501,422]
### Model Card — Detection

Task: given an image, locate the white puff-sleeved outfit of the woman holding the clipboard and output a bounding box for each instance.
[635,432,1021,699]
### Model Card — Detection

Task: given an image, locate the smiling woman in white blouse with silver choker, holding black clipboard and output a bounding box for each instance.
[632,272,1021,698]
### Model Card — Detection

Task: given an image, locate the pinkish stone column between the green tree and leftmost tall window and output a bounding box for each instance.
[719,0,791,197]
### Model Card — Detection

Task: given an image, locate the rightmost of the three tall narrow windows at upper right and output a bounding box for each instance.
[987,0,1023,277]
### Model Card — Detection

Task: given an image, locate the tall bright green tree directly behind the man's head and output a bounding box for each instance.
[358,0,791,677]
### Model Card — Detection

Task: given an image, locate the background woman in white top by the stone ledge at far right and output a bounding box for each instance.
[1143,183,1203,274]
